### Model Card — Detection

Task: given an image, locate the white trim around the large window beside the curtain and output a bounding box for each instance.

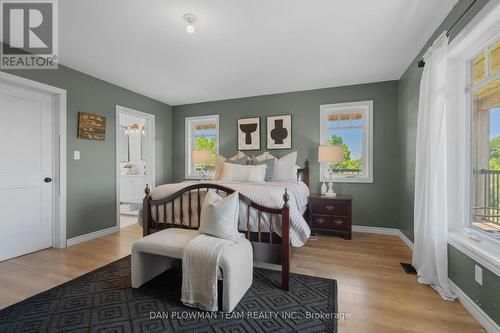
[447,0,500,276]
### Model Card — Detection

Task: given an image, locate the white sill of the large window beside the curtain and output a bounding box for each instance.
[448,230,500,276]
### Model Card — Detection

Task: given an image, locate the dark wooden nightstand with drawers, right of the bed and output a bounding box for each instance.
[309,194,352,239]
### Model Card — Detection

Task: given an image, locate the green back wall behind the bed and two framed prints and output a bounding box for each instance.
[173,81,399,228]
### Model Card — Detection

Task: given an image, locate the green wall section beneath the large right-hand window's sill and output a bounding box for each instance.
[448,245,500,325]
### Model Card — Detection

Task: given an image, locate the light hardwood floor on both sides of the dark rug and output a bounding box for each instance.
[0,225,485,333]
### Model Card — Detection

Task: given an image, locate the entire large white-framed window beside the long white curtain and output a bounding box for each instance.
[446,4,500,274]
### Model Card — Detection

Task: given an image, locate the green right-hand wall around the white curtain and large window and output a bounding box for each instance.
[397,0,500,325]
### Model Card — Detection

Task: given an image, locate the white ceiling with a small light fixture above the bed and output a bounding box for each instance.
[59,0,456,105]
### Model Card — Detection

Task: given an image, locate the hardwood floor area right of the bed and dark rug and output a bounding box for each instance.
[292,233,485,333]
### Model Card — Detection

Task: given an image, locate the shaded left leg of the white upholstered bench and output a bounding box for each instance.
[132,251,172,288]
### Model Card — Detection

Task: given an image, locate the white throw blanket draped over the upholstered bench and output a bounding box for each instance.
[181,235,233,311]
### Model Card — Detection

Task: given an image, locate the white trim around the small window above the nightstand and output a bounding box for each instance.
[319,100,373,183]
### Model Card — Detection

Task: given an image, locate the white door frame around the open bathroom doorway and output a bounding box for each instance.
[115,104,156,227]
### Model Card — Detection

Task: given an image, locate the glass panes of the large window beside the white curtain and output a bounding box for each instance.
[469,41,500,235]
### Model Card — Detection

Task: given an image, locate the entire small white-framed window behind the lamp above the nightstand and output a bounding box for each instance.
[320,101,373,183]
